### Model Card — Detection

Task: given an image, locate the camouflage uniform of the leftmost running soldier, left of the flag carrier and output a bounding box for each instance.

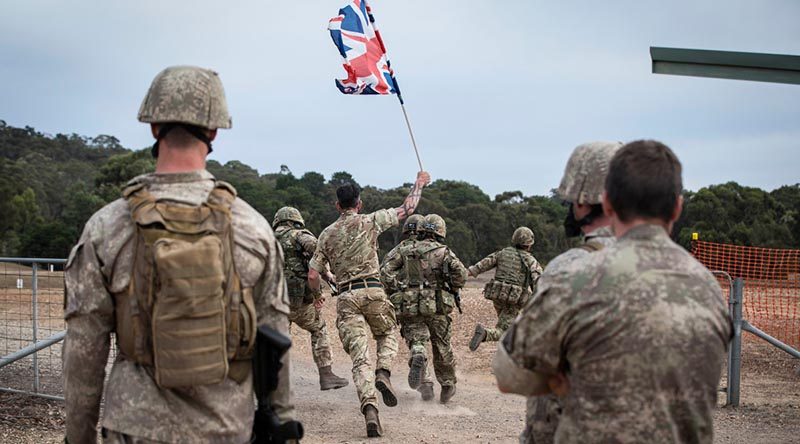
[275,225,333,368]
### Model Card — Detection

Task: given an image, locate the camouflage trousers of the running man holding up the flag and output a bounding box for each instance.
[336,288,398,411]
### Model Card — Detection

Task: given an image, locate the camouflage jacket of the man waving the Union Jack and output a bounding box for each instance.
[309,209,398,289]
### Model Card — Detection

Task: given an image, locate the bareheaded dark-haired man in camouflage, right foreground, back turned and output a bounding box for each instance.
[493,141,732,443]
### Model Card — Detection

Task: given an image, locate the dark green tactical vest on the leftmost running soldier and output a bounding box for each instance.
[275,228,314,308]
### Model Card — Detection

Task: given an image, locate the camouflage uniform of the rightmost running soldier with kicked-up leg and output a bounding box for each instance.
[469,247,542,342]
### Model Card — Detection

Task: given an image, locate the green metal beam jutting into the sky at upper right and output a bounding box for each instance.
[650,46,800,85]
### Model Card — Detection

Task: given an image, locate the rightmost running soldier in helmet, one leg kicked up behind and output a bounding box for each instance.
[469,227,542,351]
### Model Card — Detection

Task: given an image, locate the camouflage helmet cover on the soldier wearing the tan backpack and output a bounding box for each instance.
[139,66,231,130]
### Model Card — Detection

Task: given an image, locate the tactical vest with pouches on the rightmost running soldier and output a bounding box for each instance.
[483,247,533,306]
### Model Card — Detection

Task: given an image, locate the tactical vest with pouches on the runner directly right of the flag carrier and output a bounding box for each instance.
[389,241,455,320]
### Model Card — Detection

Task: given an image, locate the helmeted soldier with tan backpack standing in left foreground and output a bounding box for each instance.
[63,66,293,443]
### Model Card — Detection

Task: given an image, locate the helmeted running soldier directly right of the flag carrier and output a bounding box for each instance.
[381,214,467,404]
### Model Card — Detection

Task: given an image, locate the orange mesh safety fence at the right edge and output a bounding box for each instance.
[692,240,800,349]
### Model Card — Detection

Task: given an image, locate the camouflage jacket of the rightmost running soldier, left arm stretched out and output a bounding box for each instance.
[469,247,542,291]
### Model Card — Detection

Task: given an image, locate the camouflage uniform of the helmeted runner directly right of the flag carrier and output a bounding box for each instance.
[381,239,467,388]
